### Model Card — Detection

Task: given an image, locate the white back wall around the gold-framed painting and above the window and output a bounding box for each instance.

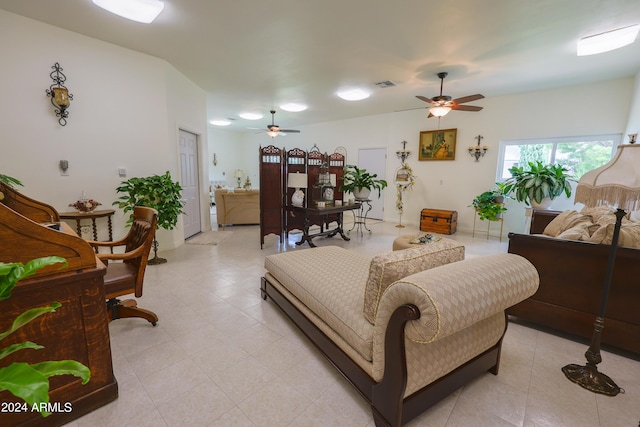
[245,78,640,236]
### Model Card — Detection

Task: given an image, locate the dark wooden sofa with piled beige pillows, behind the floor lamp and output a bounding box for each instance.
[507,207,640,356]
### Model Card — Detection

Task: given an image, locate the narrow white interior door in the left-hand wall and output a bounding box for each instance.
[180,129,201,239]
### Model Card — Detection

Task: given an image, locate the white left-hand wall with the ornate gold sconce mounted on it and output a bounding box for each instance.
[0,11,208,250]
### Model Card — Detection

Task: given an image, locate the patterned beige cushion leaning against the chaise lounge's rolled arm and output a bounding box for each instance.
[363,239,464,324]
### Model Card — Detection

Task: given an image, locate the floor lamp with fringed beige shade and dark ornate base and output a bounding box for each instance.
[562,139,640,396]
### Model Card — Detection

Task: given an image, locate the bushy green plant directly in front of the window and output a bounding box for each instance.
[503,161,575,207]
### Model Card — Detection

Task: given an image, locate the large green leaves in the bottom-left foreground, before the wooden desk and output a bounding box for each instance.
[0,257,91,417]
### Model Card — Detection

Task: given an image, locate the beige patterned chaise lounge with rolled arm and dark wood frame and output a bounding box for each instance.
[261,241,538,426]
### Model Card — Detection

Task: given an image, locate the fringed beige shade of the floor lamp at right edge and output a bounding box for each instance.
[575,144,640,212]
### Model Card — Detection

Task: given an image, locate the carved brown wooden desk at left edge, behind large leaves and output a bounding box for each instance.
[0,183,118,426]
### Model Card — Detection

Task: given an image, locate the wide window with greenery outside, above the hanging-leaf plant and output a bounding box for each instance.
[496,134,622,181]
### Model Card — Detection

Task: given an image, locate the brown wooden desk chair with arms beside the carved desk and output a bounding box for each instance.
[89,206,158,326]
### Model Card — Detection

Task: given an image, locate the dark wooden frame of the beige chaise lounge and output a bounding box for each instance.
[260,277,508,427]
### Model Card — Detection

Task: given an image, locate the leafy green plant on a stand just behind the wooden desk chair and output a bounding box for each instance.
[113,171,184,265]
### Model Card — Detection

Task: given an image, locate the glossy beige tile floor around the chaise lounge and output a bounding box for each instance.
[70,220,640,427]
